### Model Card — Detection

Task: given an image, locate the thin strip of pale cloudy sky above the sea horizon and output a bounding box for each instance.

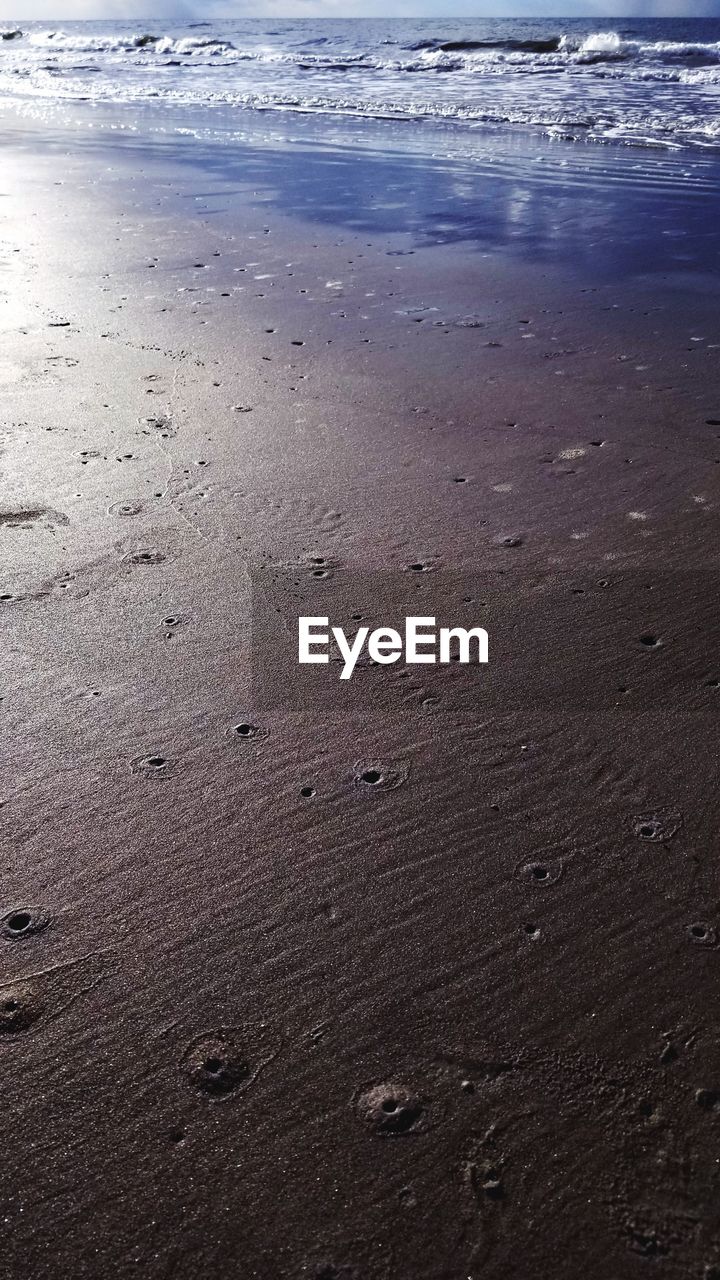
[0,0,720,26]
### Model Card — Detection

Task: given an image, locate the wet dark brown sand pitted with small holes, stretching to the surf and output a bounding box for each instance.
[0,108,720,1280]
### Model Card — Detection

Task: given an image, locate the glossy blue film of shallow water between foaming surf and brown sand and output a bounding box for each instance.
[3,102,720,291]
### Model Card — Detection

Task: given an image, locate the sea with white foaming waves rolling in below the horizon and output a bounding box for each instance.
[0,18,720,151]
